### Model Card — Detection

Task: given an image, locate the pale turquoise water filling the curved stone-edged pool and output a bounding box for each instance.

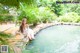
[23,25,80,53]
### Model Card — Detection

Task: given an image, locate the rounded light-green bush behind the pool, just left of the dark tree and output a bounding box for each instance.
[39,7,57,22]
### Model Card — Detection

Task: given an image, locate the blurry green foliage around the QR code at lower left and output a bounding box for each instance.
[0,32,14,53]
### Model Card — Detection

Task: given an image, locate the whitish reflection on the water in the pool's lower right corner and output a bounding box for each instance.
[55,40,80,53]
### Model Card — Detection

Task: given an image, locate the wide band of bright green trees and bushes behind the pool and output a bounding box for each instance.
[0,0,80,24]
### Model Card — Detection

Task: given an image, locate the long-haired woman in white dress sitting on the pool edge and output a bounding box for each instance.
[20,18,34,40]
